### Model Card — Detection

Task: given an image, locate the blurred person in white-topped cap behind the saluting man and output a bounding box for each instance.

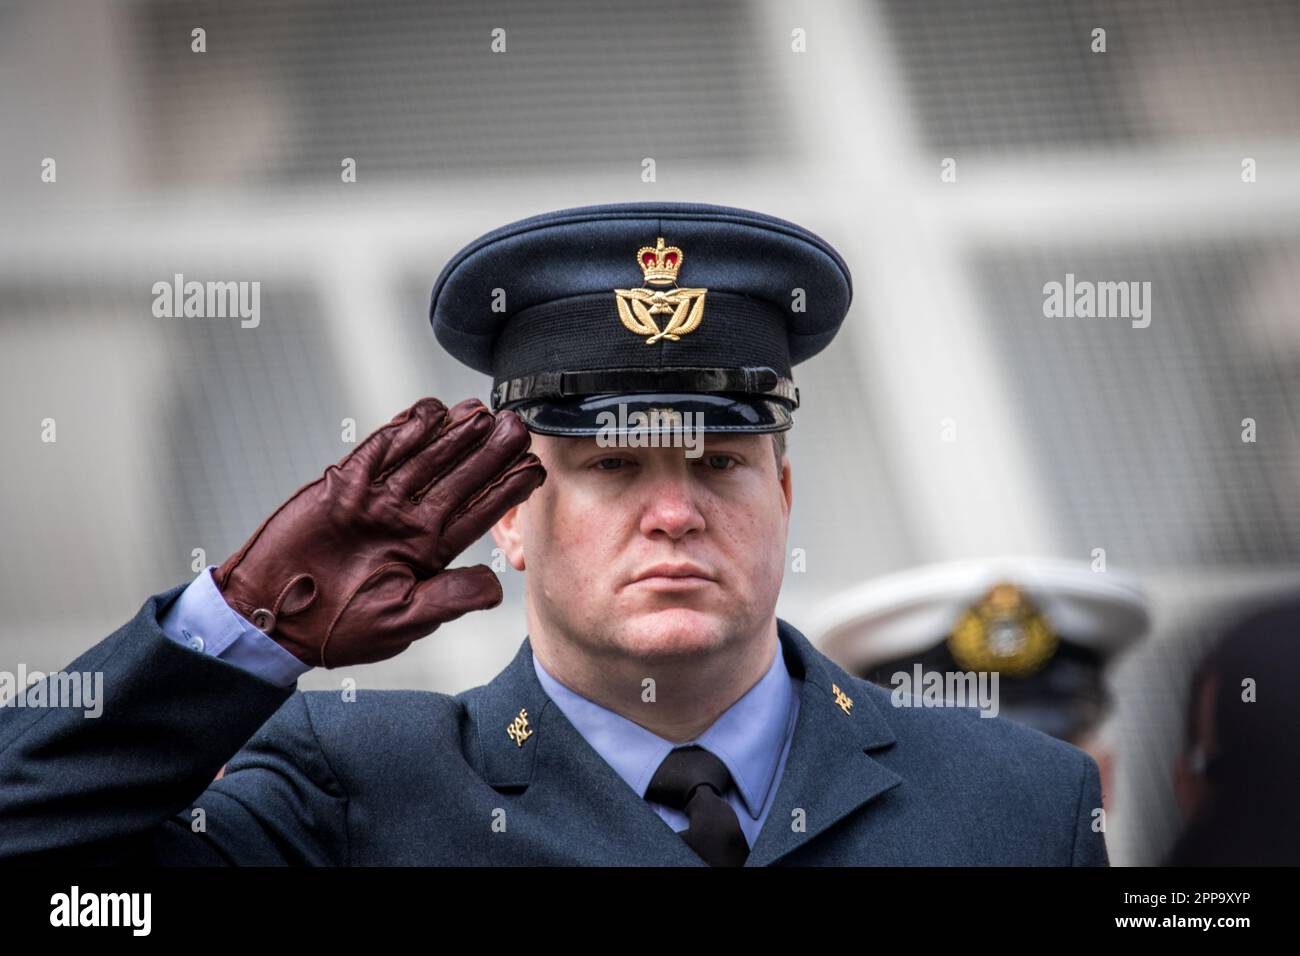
[815,558,1151,806]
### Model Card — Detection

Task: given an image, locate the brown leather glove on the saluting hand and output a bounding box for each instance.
[215,398,546,667]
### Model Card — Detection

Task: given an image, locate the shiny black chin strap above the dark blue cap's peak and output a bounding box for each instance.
[491,365,800,411]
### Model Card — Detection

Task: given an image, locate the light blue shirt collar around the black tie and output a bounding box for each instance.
[533,640,794,819]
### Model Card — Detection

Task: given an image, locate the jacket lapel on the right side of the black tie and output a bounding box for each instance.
[745,619,902,866]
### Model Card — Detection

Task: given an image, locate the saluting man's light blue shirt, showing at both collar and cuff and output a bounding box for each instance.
[159,564,803,847]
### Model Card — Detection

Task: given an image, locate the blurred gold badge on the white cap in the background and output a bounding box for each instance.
[948,583,1058,678]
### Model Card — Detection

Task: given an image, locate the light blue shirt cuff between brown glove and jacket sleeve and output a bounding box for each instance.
[159,564,311,687]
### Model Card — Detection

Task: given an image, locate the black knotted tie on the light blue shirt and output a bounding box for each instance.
[645,745,749,866]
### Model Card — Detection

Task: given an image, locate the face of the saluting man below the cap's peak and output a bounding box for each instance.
[493,434,792,658]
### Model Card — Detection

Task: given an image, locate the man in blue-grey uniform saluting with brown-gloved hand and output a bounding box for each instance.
[0,203,1106,866]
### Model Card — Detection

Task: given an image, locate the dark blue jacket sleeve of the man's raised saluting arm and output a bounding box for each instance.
[0,588,347,865]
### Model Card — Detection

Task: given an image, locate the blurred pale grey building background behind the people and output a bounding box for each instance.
[0,0,1300,864]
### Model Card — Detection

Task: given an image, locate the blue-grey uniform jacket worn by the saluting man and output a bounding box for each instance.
[0,585,1108,866]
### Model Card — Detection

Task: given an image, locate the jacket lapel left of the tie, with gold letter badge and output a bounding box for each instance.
[472,637,706,866]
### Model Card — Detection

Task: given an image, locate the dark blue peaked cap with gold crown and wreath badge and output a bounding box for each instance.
[429,203,853,434]
